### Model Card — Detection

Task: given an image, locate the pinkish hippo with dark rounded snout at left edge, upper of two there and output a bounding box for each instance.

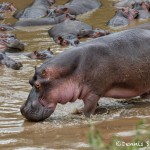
[0,34,24,52]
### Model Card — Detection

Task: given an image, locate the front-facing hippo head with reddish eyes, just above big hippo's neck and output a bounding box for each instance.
[54,34,79,46]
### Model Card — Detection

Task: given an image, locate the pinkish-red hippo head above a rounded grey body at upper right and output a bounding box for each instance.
[117,7,139,20]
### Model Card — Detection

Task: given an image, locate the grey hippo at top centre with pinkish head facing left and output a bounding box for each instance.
[49,0,101,16]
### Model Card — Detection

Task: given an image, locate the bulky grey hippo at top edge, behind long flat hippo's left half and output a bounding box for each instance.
[14,0,55,19]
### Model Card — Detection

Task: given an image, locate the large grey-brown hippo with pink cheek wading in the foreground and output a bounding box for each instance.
[20,29,150,121]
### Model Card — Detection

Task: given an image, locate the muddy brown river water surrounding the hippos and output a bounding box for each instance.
[0,0,150,150]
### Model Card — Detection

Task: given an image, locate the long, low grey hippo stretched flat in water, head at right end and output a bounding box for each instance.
[14,14,75,28]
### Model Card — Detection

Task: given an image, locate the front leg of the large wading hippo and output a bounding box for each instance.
[83,93,100,117]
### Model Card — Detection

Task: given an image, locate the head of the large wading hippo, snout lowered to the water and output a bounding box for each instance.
[20,69,57,121]
